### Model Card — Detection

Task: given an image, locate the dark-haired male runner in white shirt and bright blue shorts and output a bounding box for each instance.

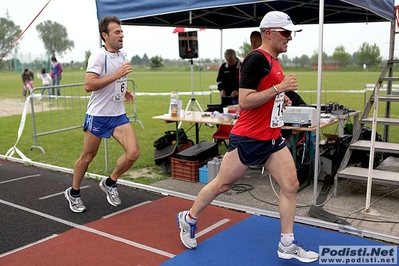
[64,16,140,212]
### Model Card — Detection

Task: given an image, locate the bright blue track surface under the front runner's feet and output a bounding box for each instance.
[162,215,396,266]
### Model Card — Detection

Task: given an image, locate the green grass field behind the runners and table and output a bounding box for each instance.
[0,68,398,183]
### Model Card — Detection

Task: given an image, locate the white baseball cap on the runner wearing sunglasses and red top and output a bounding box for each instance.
[259,11,302,31]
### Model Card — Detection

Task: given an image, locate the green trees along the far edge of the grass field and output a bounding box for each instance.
[0,17,383,70]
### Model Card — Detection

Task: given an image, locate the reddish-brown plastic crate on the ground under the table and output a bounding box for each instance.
[170,157,206,182]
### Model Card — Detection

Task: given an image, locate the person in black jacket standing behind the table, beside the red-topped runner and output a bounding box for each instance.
[216,49,241,107]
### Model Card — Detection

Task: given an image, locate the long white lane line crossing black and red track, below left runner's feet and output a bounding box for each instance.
[0,199,176,258]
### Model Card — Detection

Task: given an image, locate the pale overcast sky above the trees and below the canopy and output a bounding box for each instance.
[0,0,398,62]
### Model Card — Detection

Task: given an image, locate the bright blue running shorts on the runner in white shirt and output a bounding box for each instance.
[83,114,129,139]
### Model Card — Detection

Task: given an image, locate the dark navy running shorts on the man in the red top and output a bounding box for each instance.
[228,134,286,165]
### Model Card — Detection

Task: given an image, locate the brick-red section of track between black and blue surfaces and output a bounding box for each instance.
[0,196,250,266]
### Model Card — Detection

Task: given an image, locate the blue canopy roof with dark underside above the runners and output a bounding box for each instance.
[96,0,395,29]
